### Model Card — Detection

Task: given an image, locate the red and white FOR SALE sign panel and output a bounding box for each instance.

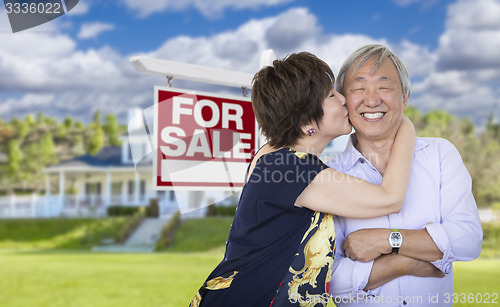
[153,87,259,190]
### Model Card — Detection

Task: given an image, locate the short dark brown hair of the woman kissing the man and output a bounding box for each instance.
[252,52,335,148]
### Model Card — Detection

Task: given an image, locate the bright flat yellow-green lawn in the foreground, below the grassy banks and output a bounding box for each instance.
[0,251,500,307]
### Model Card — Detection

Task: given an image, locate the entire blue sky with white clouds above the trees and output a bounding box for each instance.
[0,0,500,125]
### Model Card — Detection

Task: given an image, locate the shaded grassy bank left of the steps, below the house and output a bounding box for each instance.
[0,217,130,250]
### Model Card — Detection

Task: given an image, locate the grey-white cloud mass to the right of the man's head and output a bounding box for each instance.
[395,0,500,125]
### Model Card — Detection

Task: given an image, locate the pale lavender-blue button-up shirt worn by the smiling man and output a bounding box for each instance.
[327,135,483,307]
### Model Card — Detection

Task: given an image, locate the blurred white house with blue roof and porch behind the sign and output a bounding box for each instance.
[37,125,238,218]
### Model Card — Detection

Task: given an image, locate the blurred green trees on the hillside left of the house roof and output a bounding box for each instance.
[0,111,125,193]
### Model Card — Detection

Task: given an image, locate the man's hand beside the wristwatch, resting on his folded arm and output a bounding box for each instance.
[342,228,391,262]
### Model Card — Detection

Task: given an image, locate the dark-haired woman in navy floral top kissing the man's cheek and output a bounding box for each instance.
[190,52,415,307]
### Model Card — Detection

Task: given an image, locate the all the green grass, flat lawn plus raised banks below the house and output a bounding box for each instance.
[0,218,500,307]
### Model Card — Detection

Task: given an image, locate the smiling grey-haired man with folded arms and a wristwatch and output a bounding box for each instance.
[327,45,482,307]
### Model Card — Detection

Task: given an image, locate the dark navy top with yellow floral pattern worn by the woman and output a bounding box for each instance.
[190,148,335,307]
